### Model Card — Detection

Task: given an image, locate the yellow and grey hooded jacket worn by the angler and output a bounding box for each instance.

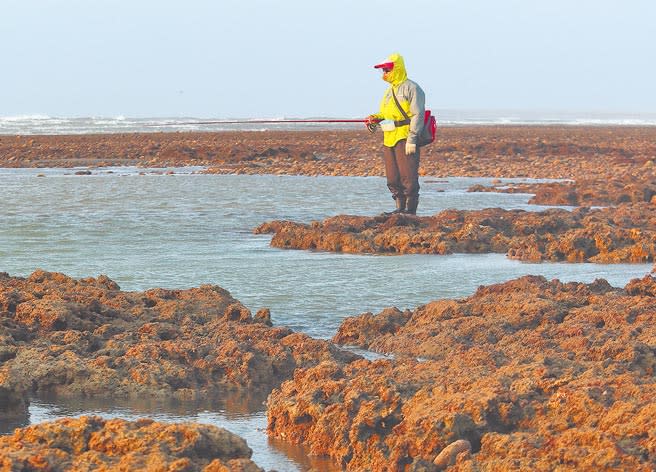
[372,53,426,147]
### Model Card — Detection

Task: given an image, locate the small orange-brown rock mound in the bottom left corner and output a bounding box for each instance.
[0,416,263,472]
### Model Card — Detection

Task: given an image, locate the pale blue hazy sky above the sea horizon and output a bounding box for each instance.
[0,0,656,118]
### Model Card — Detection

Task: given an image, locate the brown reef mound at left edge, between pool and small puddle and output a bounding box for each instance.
[0,271,357,411]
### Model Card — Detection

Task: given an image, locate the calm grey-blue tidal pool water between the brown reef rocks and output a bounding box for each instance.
[0,168,652,470]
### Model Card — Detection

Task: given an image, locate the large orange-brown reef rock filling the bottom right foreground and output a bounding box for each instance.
[268,276,656,471]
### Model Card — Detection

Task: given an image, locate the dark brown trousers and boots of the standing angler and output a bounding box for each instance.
[383,139,419,215]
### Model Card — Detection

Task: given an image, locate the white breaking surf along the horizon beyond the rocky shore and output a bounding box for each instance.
[0,110,656,135]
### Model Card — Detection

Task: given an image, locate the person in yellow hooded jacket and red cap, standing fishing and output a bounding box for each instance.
[366,53,425,215]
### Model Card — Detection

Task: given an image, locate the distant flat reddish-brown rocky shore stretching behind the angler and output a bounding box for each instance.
[0,126,656,181]
